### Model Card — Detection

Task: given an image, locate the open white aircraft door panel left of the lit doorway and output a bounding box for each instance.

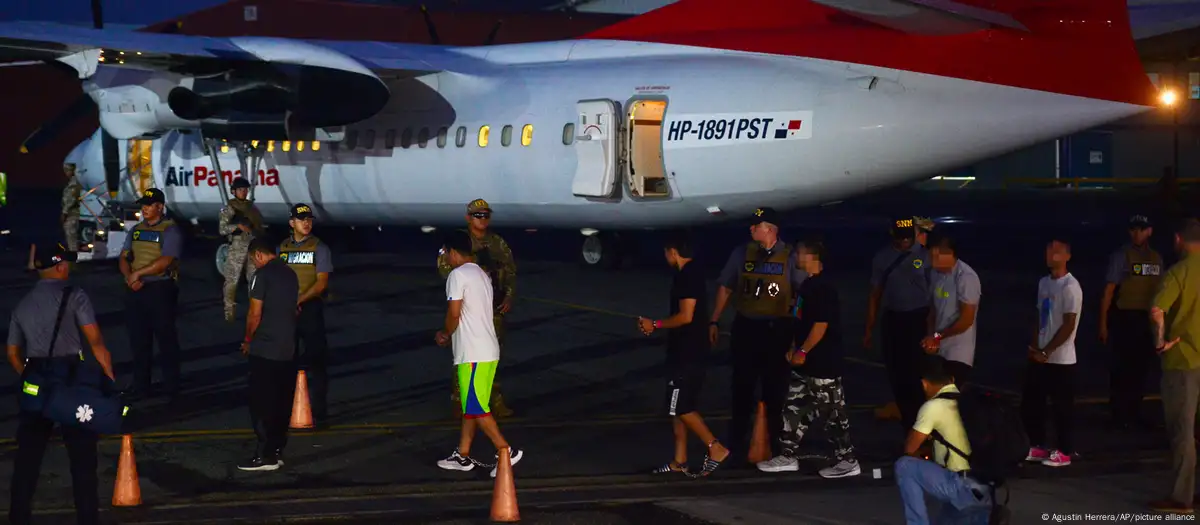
[571,99,620,197]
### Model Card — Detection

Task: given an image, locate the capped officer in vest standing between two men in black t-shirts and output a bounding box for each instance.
[708,207,806,459]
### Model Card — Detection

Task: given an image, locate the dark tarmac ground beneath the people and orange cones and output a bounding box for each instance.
[0,191,1190,525]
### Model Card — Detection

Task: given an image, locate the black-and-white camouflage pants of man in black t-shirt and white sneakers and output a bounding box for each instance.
[779,370,854,461]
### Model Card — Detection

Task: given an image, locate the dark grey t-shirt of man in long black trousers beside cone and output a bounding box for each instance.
[250,258,300,361]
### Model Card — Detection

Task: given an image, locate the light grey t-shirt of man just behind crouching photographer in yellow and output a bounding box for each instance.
[929,260,982,366]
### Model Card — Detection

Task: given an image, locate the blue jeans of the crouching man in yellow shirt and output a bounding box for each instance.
[895,455,991,525]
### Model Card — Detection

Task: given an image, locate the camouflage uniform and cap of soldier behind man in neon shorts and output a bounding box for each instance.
[438,199,517,417]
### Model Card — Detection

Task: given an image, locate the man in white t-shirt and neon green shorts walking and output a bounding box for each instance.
[436,230,524,477]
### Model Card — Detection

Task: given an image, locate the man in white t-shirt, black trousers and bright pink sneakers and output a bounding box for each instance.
[1021,239,1084,466]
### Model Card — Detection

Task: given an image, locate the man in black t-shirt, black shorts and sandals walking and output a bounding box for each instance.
[637,234,730,476]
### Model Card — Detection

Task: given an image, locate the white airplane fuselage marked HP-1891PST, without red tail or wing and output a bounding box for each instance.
[79,41,1148,229]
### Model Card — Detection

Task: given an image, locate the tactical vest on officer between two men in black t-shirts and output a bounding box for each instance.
[738,242,792,316]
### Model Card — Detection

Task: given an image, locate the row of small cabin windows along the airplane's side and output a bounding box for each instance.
[221,122,585,152]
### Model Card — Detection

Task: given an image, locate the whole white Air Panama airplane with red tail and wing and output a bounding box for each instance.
[0,0,1157,264]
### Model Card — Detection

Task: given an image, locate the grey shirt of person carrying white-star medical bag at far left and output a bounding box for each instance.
[8,279,96,358]
